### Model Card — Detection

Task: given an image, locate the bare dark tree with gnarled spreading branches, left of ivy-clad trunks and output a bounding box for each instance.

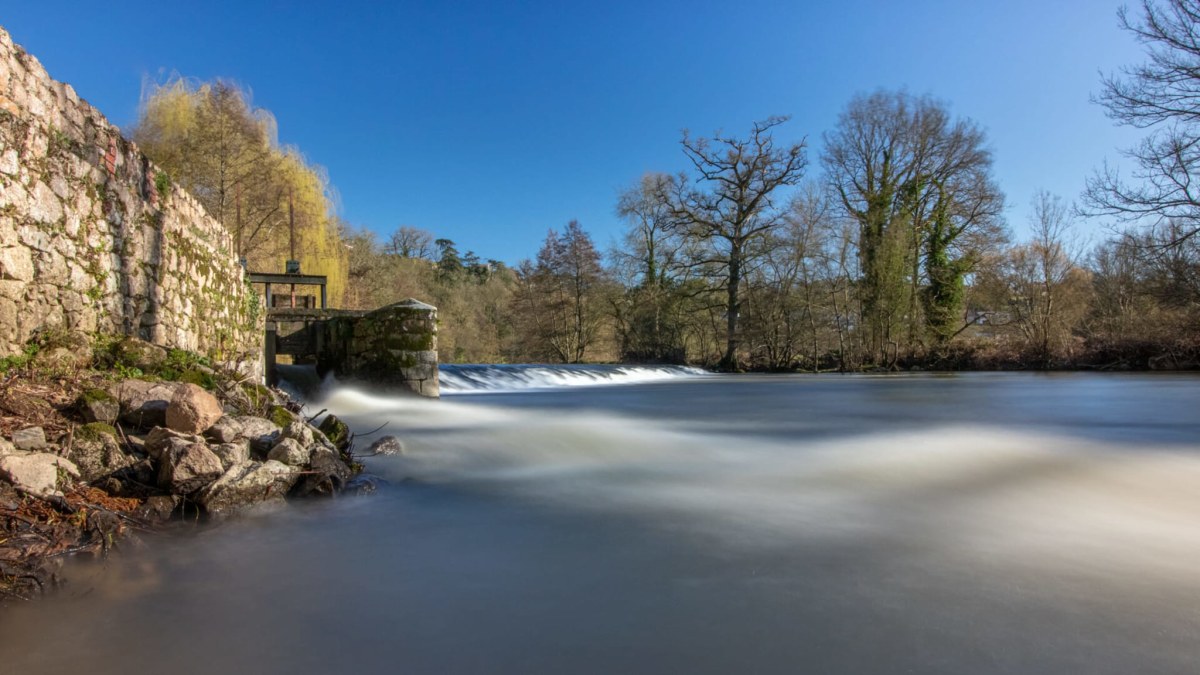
[659,117,808,370]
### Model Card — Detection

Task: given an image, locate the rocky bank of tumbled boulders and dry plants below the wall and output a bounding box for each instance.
[0,333,373,602]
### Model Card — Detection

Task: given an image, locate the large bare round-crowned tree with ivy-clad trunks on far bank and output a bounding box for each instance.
[822,90,1004,359]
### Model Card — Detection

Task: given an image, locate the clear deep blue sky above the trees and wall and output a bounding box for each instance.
[0,0,1142,262]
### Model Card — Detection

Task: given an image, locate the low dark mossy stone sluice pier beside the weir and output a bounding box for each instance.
[263,298,439,398]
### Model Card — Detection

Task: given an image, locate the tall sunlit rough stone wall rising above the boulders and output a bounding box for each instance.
[0,29,263,372]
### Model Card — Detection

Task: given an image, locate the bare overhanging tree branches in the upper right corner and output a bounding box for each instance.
[1085,0,1200,245]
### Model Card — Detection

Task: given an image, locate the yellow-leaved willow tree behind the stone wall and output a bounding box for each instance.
[132,78,347,303]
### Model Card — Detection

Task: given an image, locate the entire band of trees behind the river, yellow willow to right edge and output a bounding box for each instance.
[134,0,1200,370]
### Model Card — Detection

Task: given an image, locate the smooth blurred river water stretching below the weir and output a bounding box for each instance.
[0,374,1200,674]
